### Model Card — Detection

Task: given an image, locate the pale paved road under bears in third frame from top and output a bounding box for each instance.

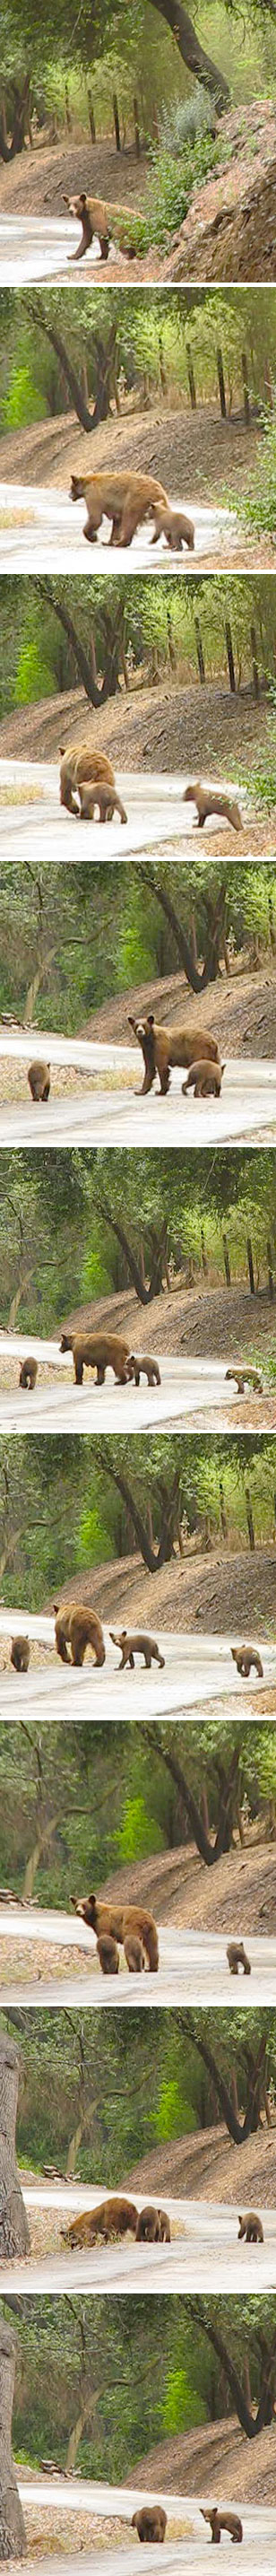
[0,752,245,866]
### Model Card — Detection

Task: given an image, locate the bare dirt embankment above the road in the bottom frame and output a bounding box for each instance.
[126,2416,276,2506]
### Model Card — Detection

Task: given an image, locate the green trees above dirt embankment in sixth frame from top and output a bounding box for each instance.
[0,1435,276,1633]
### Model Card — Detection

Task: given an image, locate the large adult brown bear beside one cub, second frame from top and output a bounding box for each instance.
[70,472,168,546]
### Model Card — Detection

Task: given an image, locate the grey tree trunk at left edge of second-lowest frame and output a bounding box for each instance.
[0,2030,31,2262]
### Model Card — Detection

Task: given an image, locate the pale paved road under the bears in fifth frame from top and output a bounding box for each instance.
[0,1332,276,1432]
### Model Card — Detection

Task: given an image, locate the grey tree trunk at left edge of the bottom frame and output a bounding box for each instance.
[0,2316,26,2561]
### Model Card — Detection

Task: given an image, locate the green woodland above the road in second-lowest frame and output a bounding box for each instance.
[0,2006,276,2205]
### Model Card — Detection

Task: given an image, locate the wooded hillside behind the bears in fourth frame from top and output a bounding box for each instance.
[0,857,276,1087]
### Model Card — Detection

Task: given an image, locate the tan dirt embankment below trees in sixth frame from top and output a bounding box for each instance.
[44,1538,276,1638]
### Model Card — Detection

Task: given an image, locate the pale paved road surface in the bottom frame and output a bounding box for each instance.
[18,2476,276,2576]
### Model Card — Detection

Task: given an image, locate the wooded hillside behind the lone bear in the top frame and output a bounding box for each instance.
[0,0,276,275]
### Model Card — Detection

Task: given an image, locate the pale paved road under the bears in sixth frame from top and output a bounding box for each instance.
[0,1607,276,1723]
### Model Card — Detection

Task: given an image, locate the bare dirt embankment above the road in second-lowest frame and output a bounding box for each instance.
[124,2118,276,2205]
